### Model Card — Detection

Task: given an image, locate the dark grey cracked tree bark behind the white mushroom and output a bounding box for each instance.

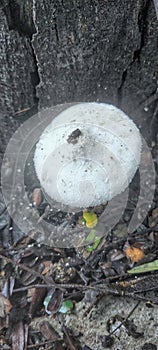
[0,0,158,141]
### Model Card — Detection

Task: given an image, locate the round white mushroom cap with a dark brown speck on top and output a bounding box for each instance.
[34,102,141,209]
